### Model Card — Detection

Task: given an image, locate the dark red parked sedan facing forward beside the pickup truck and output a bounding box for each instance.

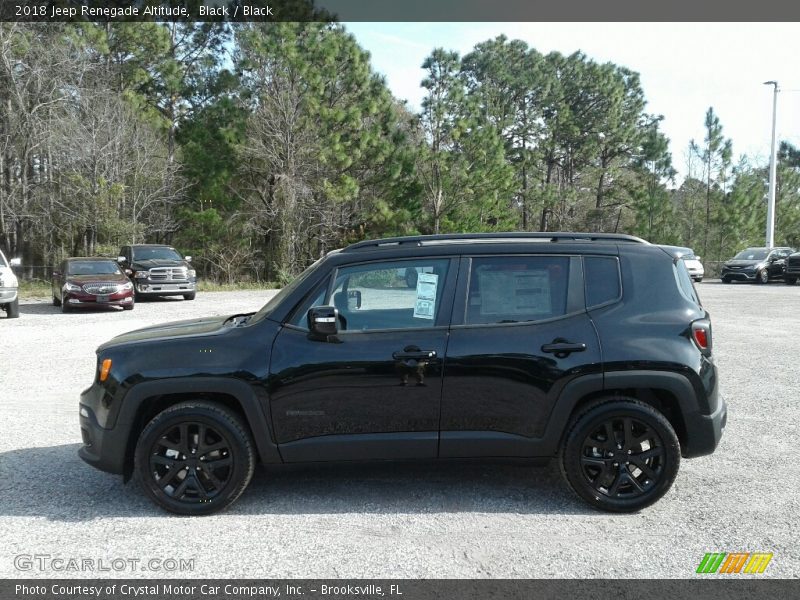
[51,257,134,312]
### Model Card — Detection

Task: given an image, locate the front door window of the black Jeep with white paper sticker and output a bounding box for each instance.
[326,259,450,331]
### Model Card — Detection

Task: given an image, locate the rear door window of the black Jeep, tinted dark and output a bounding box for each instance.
[466,256,570,325]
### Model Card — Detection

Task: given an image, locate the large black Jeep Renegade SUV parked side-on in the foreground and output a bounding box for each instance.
[80,233,727,514]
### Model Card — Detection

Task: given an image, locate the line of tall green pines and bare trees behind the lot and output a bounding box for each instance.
[0,23,800,284]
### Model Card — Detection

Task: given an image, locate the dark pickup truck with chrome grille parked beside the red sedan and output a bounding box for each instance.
[117,244,197,300]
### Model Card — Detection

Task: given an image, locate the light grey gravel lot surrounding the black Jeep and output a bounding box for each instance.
[0,281,800,578]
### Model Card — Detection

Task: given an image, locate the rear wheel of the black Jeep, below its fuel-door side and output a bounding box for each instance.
[560,398,681,512]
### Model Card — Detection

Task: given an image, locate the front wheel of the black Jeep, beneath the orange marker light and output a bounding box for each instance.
[134,401,256,515]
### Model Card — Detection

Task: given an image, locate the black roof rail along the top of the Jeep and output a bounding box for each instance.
[343,231,650,252]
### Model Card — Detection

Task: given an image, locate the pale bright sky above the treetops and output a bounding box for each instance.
[345,23,800,183]
